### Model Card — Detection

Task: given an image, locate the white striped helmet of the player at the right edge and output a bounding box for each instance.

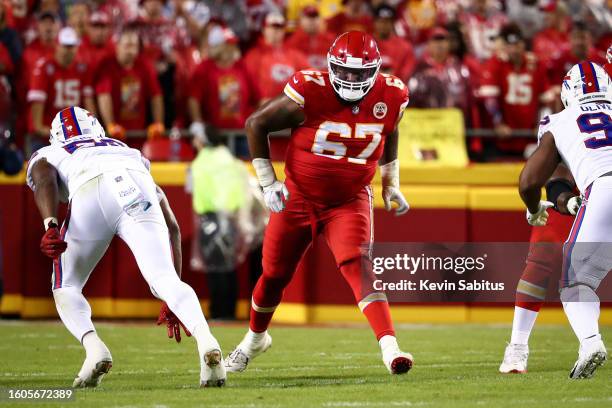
[561,61,612,108]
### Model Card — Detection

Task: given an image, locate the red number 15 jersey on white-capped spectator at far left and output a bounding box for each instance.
[27,58,93,126]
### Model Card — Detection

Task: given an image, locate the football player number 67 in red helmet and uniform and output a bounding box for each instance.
[225,31,413,374]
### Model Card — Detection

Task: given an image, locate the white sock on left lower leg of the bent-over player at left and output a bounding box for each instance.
[53,287,95,343]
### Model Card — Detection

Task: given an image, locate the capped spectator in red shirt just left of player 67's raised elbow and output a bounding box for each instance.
[189,26,254,143]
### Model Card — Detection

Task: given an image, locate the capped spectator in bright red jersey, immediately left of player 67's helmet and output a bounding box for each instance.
[245,13,308,103]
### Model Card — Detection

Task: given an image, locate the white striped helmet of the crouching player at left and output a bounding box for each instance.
[49,106,106,144]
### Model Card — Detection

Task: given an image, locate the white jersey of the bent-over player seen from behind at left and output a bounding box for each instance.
[26,136,150,202]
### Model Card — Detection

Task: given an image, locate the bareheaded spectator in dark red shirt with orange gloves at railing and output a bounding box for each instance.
[96,26,164,139]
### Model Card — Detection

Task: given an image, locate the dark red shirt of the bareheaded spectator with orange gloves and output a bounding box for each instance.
[96,57,161,130]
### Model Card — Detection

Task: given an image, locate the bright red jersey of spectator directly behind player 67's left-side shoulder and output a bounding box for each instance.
[244,41,308,100]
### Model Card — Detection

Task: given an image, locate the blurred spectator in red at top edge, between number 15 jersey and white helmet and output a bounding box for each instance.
[532,1,570,65]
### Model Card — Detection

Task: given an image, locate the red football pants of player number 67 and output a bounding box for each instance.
[250,182,394,339]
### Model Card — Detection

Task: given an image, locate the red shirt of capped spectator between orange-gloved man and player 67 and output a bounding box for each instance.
[189,60,254,129]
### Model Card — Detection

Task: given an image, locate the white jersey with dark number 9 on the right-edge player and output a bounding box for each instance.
[538,103,612,192]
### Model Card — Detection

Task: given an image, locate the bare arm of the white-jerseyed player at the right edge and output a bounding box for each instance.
[519,132,561,214]
